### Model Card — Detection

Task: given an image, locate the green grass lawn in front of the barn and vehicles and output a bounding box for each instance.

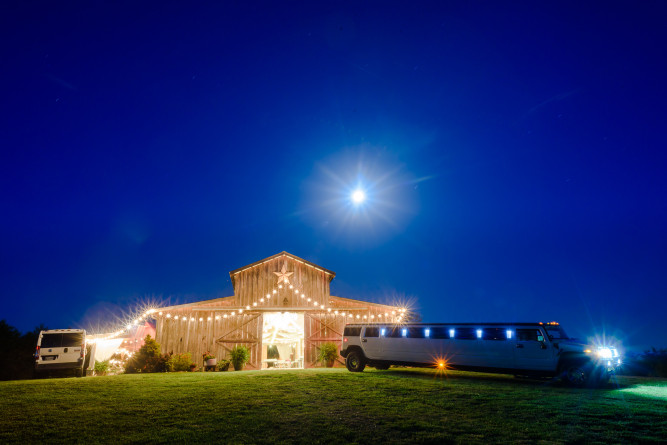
[0,369,667,444]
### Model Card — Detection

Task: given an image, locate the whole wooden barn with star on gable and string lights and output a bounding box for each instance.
[154,252,402,370]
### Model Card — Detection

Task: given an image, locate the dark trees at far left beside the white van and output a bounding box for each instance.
[0,320,47,380]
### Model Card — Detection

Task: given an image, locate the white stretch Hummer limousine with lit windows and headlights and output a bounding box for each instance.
[340,322,622,386]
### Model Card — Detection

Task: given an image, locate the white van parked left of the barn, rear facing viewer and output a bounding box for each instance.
[35,329,86,377]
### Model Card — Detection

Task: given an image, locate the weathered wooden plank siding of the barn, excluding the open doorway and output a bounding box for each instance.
[156,253,398,369]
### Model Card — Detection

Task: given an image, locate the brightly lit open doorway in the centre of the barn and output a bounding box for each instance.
[262,312,304,369]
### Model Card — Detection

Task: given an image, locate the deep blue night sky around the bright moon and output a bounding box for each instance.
[0,1,667,347]
